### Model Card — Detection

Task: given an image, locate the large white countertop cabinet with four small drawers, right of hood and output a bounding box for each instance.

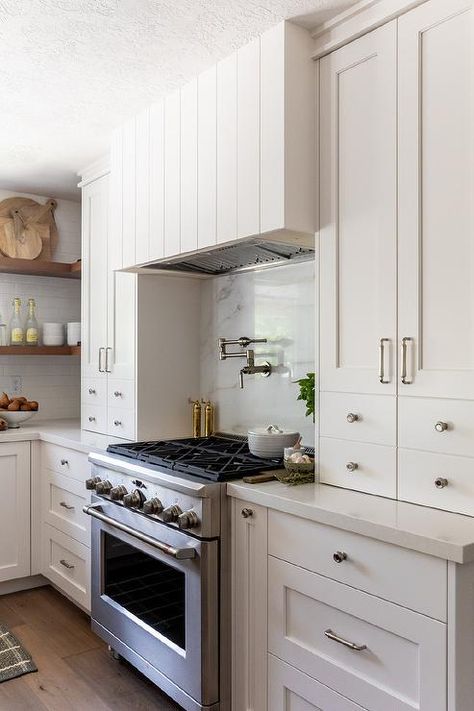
[320,0,474,515]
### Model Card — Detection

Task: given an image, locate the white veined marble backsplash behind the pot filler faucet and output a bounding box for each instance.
[201,262,315,445]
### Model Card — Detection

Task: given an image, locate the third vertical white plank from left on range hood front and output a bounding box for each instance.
[135,109,150,264]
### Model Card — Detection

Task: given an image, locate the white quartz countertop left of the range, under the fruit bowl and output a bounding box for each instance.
[0,418,120,453]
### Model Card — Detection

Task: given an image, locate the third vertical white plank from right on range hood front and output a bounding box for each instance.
[217,52,237,242]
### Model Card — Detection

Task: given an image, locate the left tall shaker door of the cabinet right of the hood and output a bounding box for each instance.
[320,22,397,394]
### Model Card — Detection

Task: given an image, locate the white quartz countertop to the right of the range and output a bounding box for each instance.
[227,481,474,563]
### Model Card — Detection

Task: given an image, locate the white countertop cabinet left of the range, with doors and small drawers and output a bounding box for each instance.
[81,166,200,440]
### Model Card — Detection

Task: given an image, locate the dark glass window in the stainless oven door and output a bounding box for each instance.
[103,533,186,649]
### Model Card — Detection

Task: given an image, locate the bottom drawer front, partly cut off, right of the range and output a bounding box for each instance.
[268,654,364,711]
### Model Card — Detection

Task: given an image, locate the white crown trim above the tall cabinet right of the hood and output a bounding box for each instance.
[311,0,427,59]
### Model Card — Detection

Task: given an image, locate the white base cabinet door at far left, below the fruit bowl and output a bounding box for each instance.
[0,442,30,582]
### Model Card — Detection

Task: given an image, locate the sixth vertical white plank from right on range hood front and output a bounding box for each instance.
[164,91,181,257]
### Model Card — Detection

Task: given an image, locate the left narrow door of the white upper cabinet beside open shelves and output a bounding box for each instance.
[82,175,109,378]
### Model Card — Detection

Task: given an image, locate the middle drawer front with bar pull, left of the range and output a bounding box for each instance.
[42,471,91,547]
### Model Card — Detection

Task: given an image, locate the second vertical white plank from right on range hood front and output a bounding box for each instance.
[237,38,260,237]
